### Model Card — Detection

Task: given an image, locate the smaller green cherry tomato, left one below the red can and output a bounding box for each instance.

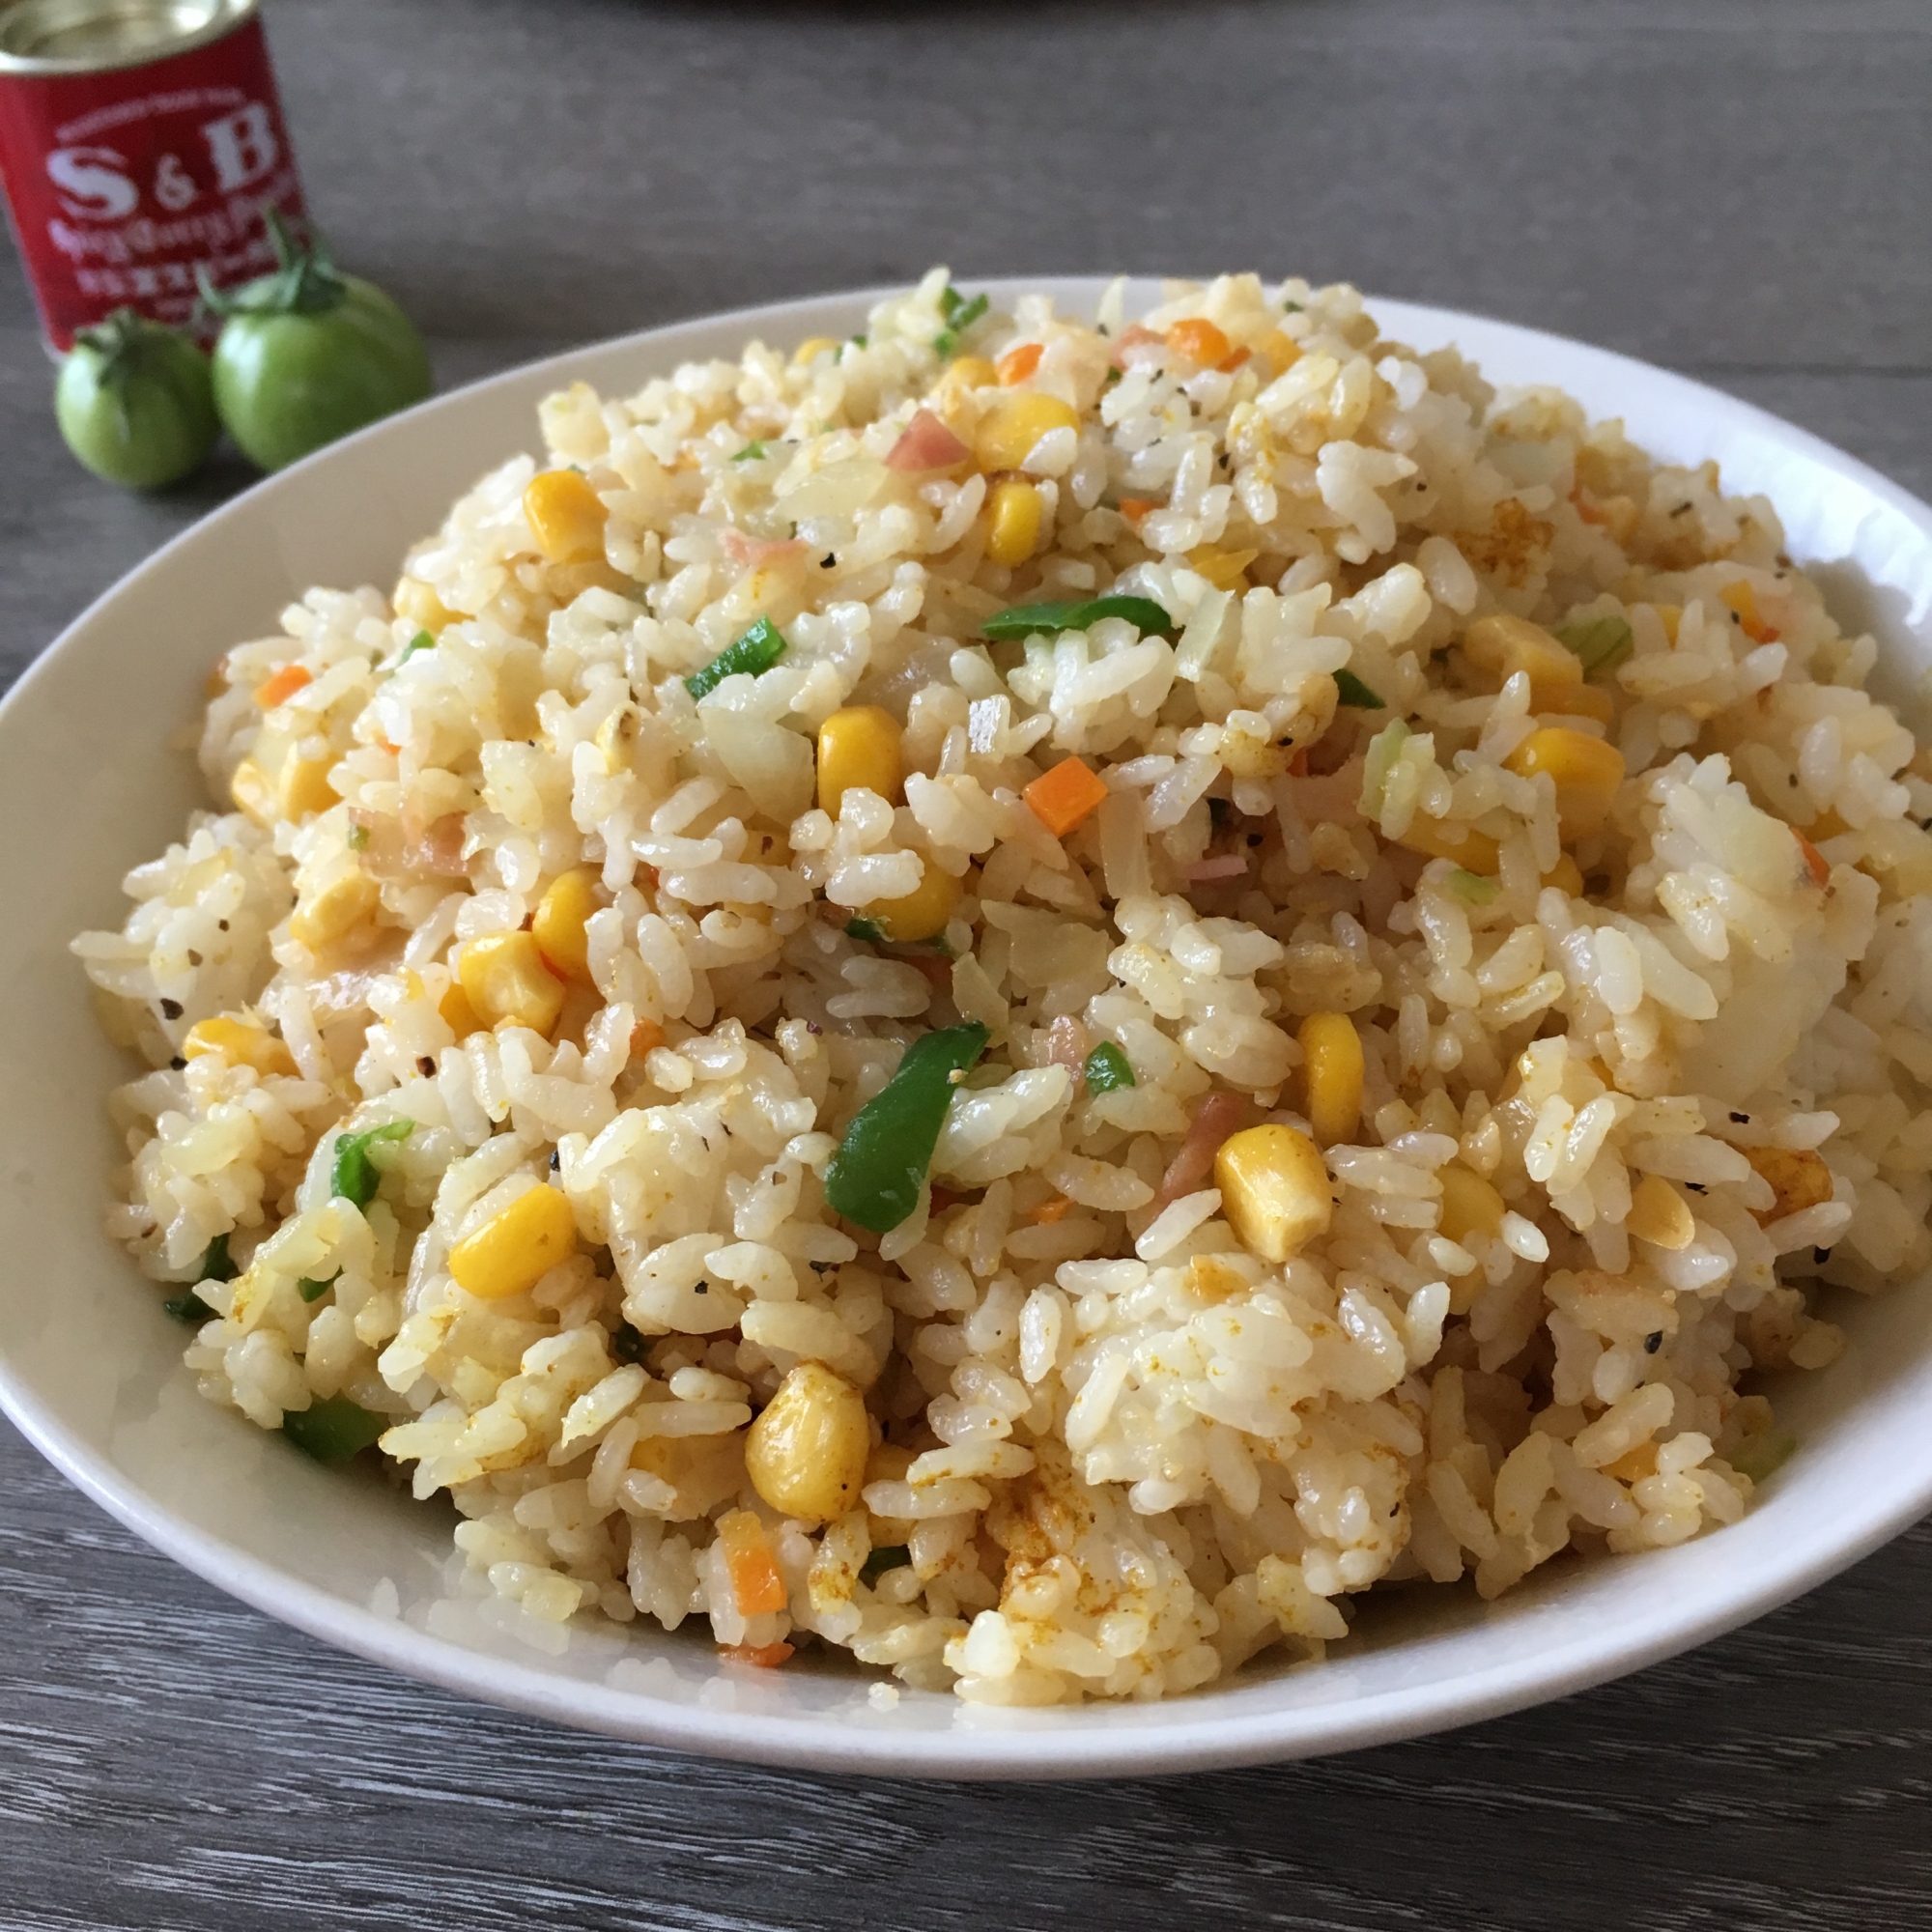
[54,309,220,489]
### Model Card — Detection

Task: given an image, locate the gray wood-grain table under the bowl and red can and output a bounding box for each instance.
[0,0,1932,1932]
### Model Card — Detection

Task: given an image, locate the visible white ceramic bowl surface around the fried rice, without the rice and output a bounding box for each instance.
[11,280,1932,1777]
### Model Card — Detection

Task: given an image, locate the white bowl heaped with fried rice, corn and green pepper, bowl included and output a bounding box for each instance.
[0,269,1932,1776]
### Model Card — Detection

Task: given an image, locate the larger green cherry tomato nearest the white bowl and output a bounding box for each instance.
[203,211,429,469]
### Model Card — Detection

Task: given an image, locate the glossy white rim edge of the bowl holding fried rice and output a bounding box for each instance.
[0,274,1932,1779]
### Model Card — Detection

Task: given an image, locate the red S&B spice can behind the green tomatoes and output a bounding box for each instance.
[0,0,307,352]
